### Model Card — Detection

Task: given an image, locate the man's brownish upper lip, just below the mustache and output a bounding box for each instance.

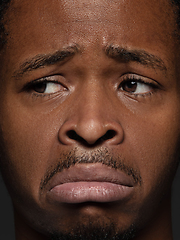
[48,163,135,191]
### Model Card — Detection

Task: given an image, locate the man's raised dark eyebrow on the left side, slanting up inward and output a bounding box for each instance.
[14,45,80,78]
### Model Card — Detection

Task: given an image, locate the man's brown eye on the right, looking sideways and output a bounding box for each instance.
[120,76,157,95]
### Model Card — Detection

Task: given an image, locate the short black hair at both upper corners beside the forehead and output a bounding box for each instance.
[0,0,180,49]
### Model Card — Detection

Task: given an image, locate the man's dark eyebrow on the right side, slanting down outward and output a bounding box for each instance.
[105,45,167,71]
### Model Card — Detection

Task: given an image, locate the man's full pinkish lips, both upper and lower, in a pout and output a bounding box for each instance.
[47,163,134,204]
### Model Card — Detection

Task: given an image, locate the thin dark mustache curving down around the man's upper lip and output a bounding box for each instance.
[40,148,141,190]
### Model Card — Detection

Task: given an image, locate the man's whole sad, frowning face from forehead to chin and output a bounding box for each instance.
[0,0,180,239]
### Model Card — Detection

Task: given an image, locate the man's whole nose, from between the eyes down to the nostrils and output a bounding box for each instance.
[59,78,123,146]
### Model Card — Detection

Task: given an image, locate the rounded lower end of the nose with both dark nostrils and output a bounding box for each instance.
[59,118,123,145]
